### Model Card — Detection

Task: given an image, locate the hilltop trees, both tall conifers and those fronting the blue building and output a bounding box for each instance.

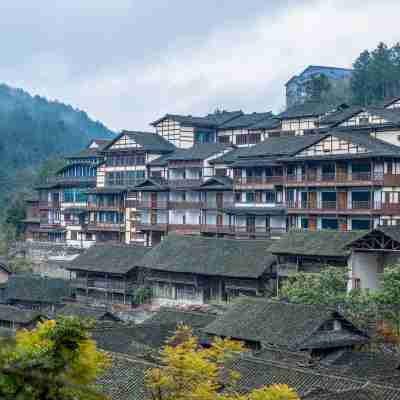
[306,42,400,106]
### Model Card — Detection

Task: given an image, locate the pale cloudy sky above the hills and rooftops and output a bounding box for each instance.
[0,0,400,131]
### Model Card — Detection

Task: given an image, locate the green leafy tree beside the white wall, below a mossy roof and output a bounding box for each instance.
[279,267,347,305]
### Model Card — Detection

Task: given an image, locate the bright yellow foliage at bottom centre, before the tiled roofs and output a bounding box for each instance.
[146,326,298,400]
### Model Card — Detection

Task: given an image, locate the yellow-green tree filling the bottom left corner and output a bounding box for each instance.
[0,317,110,400]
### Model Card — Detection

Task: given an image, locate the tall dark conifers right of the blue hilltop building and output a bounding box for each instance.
[351,42,400,106]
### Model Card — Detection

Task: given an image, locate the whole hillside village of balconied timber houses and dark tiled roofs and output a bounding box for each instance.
[0,66,400,400]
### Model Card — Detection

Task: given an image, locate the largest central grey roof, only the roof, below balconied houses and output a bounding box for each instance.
[141,235,275,278]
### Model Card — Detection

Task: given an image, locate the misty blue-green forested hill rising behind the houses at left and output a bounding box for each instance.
[0,84,113,203]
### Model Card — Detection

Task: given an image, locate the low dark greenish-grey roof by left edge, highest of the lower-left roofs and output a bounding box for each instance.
[4,274,71,303]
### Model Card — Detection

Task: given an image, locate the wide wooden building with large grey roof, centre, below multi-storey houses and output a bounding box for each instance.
[140,235,275,304]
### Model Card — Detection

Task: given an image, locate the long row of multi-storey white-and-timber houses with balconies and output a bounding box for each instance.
[25,98,400,247]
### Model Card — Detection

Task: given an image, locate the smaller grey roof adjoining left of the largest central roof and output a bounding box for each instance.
[66,243,150,274]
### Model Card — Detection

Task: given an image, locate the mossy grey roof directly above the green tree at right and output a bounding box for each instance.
[269,231,365,257]
